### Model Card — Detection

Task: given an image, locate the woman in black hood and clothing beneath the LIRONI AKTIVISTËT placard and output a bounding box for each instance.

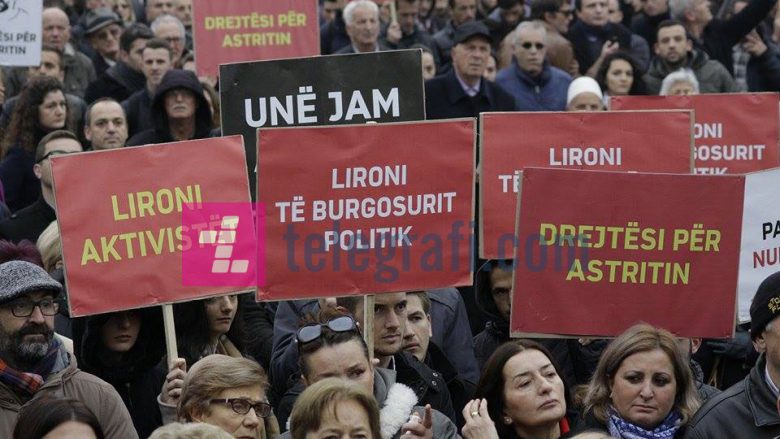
[78,307,166,438]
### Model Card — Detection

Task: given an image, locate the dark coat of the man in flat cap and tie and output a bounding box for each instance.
[425,69,515,119]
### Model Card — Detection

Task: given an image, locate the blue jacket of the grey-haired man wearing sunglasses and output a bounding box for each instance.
[496,60,571,111]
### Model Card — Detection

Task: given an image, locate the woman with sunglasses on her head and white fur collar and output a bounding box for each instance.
[282,315,458,439]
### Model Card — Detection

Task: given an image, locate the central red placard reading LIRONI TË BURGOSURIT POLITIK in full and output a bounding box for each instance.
[257,119,476,300]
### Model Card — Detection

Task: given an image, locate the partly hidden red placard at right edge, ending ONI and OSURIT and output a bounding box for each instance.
[610,93,780,174]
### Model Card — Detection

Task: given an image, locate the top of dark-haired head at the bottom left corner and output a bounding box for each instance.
[13,398,105,439]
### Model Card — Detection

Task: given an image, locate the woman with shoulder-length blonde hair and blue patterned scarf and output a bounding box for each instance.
[583,323,700,439]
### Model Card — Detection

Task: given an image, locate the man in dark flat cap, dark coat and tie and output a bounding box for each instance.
[425,21,515,119]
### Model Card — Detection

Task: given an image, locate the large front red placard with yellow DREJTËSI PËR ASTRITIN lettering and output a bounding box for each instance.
[511,168,745,338]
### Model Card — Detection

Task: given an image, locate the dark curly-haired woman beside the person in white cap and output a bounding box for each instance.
[596,52,647,105]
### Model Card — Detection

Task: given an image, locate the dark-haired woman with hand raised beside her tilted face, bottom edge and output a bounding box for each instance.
[462,340,576,439]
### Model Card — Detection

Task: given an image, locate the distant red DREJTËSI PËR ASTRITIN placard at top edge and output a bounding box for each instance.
[192,0,320,77]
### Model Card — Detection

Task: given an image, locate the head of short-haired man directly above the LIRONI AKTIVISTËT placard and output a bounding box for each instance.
[84,98,127,151]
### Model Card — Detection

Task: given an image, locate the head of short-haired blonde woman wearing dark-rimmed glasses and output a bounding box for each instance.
[178,354,279,439]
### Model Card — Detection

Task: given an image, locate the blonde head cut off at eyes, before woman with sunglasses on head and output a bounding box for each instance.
[290,378,382,439]
